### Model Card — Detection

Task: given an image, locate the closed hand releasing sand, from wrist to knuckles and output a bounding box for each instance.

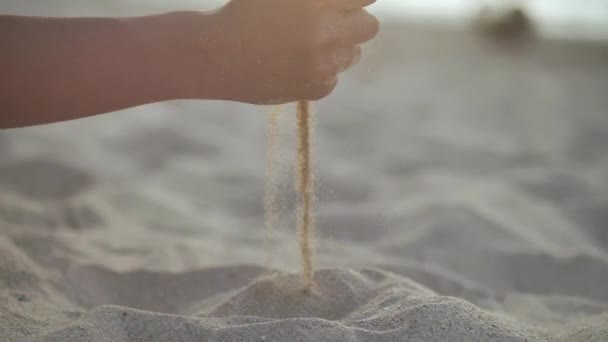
[195,0,379,104]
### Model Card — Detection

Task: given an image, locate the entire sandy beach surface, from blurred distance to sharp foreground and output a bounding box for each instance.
[0,8,608,342]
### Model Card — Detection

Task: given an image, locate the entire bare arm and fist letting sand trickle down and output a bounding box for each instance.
[0,0,378,128]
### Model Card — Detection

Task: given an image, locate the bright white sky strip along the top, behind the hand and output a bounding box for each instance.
[0,0,608,41]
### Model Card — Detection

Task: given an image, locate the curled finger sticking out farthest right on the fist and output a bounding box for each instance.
[320,9,380,46]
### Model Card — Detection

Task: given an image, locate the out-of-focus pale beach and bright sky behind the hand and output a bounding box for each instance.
[0,0,608,299]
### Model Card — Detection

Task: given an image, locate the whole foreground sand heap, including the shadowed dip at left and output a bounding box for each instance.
[0,240,535,341]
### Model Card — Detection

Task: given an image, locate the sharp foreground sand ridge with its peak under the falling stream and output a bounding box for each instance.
[32,269,536,341]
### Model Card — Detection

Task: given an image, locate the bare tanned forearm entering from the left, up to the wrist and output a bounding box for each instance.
[0,12,213,128]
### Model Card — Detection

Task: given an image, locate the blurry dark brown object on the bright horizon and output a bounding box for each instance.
[473,5,535,47]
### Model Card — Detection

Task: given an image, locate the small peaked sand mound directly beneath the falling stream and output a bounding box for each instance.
[209,269,432,320]
